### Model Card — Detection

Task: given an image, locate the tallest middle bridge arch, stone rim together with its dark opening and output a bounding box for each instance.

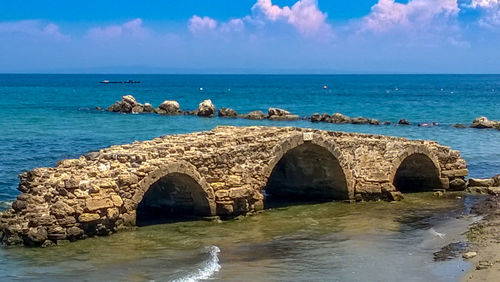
[263,132,354,200]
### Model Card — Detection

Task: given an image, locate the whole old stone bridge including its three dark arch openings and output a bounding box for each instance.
[0,127,468,245]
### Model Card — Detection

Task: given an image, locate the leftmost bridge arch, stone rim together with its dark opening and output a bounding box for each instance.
[133,162,215,226]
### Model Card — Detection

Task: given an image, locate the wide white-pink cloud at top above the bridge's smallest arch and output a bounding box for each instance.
[362,0,458,32]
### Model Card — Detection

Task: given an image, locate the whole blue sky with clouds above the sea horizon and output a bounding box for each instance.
[0,0,500,74]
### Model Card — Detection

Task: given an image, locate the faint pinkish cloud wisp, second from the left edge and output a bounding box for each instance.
[86,18,148,40]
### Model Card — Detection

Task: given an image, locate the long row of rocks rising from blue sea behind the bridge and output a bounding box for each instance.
[103,95,500,130]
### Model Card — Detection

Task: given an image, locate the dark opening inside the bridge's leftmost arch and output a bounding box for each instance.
[136,173,211,226]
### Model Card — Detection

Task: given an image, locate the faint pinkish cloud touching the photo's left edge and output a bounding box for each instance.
[0,20,69,40]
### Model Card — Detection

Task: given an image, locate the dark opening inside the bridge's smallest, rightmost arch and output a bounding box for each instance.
[393,153,441,193]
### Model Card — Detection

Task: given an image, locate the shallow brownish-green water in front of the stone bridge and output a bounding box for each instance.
[0,193,478,281]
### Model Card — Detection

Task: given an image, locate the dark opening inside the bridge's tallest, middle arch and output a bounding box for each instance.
[265,143,349,206]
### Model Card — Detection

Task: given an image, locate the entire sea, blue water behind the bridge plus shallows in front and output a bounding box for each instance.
[0,74,500,281]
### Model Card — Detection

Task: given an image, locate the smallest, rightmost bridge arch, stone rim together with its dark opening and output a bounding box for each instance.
[390,147,442,192]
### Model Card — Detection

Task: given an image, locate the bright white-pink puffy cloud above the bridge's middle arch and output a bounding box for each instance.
[252,0,331,34]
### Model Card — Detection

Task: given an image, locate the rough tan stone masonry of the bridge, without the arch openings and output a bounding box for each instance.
[0,127,468,245]
